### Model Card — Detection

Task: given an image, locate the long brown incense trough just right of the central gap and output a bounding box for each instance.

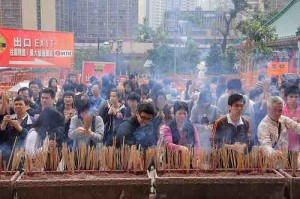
[155,169,285,199]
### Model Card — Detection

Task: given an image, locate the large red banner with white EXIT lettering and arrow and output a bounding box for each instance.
[0,27,74,68]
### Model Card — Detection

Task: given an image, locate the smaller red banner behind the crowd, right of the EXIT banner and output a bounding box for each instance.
[82,61,116,83]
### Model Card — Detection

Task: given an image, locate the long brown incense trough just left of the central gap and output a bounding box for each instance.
[16,171,150,199]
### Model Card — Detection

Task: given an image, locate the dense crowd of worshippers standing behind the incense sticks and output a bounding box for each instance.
[0,73,300,166]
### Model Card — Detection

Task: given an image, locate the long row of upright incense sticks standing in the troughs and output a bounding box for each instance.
[9,141,297,174]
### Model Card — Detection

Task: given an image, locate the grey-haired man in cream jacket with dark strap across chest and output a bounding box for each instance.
[258,96,300,157]
